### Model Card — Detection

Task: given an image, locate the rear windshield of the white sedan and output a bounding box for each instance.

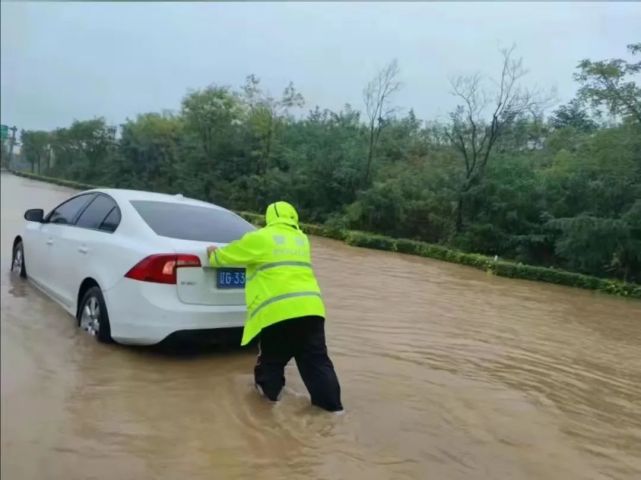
[131,200,254,243]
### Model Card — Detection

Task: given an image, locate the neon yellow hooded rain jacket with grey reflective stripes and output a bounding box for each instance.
[209,202,325,345]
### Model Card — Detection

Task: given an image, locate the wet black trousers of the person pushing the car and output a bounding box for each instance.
[254,317,343,412]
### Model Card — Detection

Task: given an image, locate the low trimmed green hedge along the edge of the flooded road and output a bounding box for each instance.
[12,171,641,299]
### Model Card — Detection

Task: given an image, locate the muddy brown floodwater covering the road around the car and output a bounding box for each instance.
[1,173,641,480]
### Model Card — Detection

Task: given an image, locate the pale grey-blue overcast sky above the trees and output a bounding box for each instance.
[1,1,641,129]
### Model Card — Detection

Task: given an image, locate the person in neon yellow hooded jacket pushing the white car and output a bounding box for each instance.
[207,201,343,412]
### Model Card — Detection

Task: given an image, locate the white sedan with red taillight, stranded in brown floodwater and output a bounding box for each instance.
[12,189,254,345]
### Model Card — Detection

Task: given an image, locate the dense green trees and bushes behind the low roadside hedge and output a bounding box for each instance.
[15,45,641,282]
